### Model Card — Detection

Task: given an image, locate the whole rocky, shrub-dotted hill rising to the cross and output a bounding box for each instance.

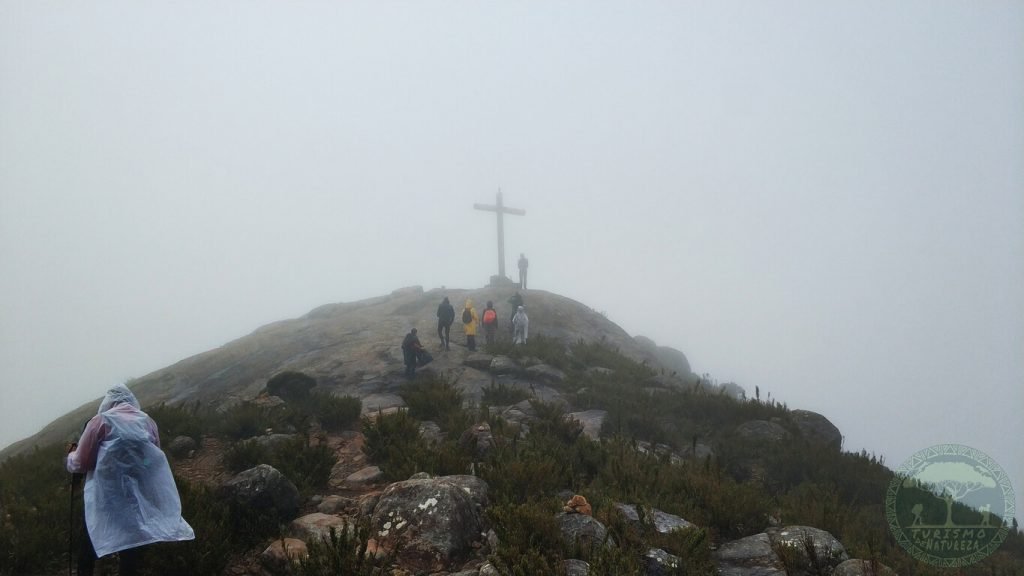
[6,286,1007,576]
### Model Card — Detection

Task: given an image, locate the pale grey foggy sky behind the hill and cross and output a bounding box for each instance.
[0,0,1024,516]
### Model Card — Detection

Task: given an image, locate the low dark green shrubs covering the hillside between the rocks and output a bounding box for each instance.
[0,350,1024,576]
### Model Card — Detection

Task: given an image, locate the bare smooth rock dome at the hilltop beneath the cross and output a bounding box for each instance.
[0,286,696,458]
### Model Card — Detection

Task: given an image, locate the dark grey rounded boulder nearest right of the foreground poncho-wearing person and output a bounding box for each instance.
[220,464,299,522]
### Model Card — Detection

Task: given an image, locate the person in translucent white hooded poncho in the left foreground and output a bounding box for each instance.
[66,384,196,576]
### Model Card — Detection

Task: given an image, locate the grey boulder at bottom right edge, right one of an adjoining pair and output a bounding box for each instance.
[765,526,850,576]
